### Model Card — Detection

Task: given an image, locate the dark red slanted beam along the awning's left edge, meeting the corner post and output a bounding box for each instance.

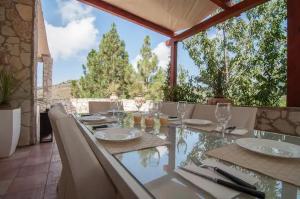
[79,0,174,37]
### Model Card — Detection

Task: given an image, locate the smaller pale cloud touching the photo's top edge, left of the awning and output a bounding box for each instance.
[56,0,92,23]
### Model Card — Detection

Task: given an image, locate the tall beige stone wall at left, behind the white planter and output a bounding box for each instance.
[0,0,36,145]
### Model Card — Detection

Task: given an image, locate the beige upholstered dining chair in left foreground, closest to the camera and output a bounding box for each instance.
[56,117,117,199]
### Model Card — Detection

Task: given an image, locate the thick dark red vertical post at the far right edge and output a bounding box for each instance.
[287,0,300,107]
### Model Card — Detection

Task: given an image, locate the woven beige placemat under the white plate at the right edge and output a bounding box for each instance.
[206,144,300,186]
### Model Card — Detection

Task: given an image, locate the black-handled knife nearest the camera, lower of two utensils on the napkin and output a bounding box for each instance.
[178,166,265,199]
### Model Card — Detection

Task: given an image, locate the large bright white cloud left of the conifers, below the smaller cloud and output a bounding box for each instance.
[46,17,98,59]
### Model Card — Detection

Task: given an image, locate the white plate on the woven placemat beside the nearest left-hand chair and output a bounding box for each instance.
[94,128,143,142]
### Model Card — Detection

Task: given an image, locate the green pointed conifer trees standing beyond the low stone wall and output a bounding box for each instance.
[71,24,165,99]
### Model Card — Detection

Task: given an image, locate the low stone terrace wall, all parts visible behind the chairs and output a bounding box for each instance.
[44,98,300,136]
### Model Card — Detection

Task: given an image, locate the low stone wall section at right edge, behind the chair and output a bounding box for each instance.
[255,107,300,136]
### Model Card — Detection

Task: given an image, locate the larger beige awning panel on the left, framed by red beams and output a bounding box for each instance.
[103,0,219,32]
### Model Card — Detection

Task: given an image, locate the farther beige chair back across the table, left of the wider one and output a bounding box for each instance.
[160,102,195,119]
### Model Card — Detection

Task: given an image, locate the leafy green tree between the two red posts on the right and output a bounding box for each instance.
[184,0,287,106]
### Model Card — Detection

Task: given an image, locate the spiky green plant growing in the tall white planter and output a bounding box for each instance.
[0,69,16,106]
